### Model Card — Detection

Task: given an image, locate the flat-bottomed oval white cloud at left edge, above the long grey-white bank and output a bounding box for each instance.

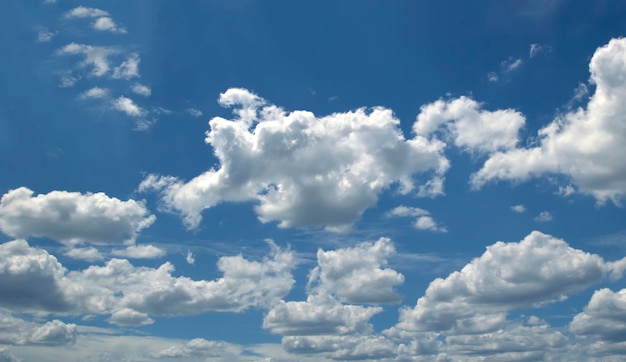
[0,187,156,245]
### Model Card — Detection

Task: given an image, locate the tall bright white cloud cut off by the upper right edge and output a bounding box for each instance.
[471,38,626,204]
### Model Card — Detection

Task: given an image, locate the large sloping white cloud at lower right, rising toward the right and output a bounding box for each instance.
[387,231,609,337]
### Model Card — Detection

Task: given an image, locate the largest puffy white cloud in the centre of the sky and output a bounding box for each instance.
[139,89,448,231]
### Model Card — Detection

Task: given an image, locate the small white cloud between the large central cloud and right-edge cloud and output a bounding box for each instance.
[413,97,525,153]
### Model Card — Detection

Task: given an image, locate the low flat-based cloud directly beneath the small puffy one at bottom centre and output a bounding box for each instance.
[263,295,382,336]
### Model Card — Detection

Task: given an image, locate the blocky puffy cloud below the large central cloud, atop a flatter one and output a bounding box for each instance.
[309,238,404,303]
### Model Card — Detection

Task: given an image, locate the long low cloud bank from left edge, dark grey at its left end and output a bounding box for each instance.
[0,240,295,325]
